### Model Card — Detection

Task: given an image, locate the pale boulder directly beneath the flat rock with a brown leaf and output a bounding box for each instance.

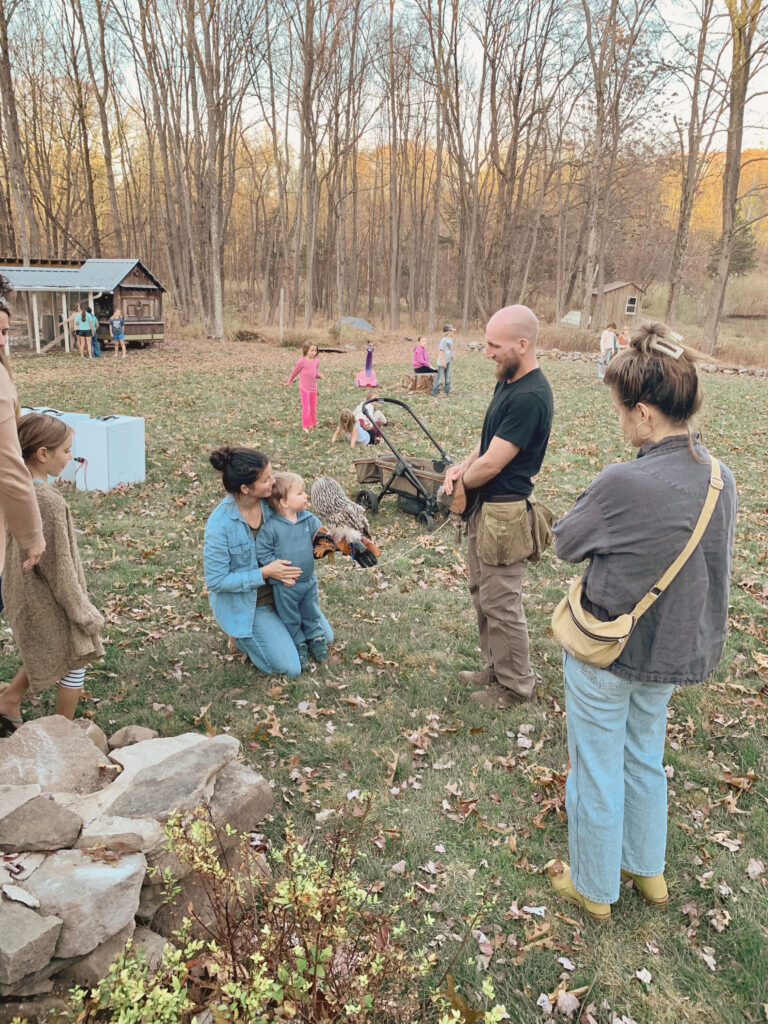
[25,850,146,957]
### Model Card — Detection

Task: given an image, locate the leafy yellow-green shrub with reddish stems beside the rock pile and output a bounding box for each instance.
[64,810,506,1024]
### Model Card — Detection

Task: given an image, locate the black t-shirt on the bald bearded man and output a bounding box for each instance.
[480,369,554,498]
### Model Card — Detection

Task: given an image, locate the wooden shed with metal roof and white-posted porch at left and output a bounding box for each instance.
[0,258,165,352]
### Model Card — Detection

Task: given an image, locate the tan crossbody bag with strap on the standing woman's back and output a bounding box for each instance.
[552,455,723,669]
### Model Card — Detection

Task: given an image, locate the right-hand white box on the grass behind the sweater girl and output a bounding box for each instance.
[70,416,146,490]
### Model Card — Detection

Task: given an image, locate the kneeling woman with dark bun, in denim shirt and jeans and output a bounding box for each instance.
[203,446,334,676]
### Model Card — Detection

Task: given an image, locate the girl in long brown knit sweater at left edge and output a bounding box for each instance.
[3,413,104,719]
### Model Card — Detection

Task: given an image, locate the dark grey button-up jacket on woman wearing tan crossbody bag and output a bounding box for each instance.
[553,434,736,686]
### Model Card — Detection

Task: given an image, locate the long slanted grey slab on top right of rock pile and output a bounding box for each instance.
[67,732,240,822]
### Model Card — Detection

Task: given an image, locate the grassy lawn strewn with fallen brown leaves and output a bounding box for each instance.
[0,341,768,1024]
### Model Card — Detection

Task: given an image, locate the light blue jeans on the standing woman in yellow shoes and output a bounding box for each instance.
[563,654,675,903]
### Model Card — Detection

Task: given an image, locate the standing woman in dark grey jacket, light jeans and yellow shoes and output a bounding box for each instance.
[547,324,736,921]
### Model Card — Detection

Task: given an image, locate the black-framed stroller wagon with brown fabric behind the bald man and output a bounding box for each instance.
[354,398,454,529]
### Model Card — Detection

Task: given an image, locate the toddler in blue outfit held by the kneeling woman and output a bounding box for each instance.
[256,473,328,670]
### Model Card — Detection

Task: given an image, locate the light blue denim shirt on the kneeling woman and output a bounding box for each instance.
[203,495,273,638]
